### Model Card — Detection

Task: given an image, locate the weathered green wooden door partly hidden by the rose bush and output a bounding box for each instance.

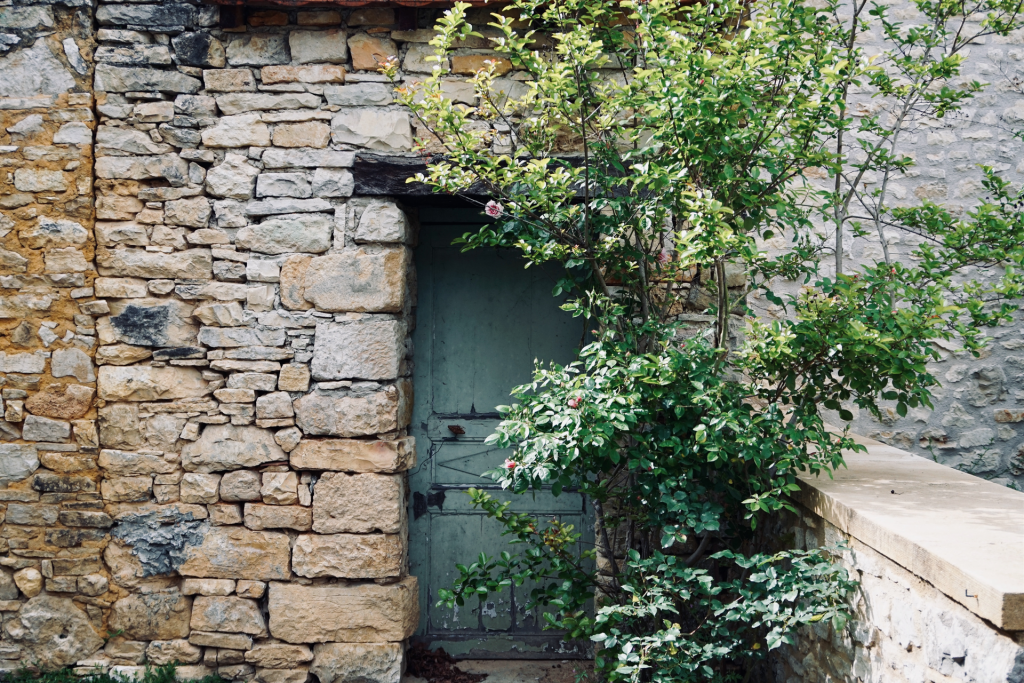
[409,209,593,658]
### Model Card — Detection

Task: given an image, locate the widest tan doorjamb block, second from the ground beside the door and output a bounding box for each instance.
[268,577,420,643]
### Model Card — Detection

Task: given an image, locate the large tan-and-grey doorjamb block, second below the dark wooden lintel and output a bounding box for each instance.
[303,247,410,313]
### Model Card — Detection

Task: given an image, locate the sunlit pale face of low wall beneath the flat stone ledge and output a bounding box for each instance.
[773,509,1024,683]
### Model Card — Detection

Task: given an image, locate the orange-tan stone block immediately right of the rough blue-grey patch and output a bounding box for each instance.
[178,526,291,581]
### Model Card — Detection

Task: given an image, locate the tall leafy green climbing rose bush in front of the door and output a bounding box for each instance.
[385,0,1024,683]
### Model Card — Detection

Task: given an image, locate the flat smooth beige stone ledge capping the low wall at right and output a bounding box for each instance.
[797,436,1024,631]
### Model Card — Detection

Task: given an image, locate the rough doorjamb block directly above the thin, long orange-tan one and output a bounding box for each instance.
[293,381,413,436]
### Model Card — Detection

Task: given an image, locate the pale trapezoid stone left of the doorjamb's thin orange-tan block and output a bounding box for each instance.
[182,423,288,473]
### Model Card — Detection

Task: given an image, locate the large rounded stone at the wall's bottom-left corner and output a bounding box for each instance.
[4,595,103,670]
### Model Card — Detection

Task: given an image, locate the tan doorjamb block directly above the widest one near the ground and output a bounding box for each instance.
[292,533,406,579]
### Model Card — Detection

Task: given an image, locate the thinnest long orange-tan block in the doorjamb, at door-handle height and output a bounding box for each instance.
[291,436,416,473]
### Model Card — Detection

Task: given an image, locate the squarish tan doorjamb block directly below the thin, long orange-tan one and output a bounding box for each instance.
[313,472,404,533]
